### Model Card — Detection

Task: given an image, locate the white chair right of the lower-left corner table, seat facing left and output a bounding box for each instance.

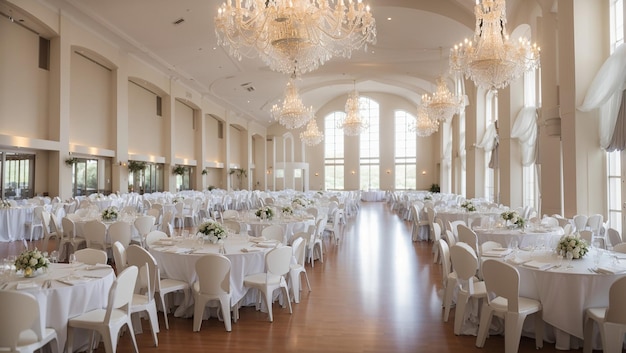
[65,266,139,353]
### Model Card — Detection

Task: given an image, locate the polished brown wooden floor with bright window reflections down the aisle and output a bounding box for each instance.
[0,203,576,353]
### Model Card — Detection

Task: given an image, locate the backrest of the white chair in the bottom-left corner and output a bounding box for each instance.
[0,291,42,352]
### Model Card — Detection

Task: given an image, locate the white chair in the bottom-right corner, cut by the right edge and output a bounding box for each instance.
[583,277,626,353]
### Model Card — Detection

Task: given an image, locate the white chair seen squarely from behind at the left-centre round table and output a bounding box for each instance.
[192,254,232,332]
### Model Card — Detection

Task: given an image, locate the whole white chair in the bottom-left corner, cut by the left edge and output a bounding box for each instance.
[0,290,58,353]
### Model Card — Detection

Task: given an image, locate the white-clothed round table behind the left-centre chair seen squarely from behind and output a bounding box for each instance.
[149,235,276,317]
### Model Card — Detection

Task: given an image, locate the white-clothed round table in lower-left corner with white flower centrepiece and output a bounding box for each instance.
[0,264,115,352]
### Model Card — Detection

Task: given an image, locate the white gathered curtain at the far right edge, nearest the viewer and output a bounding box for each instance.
[578,44,626,149]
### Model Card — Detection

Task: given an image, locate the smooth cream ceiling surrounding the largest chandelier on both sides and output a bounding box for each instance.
[6,0,516,126]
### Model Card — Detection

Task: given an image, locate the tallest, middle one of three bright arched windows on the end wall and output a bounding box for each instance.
[359,97,380,190]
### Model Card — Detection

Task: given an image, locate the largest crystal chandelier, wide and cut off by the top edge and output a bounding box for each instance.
[215,0,376,75]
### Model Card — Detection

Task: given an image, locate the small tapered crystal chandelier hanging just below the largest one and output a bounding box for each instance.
[272,77,313,130]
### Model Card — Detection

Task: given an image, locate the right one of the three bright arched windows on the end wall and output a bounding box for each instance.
[394,110,417,190]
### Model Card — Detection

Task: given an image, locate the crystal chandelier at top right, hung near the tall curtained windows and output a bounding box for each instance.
[450,0,540,90]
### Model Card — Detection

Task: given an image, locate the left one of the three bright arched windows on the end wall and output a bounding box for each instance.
[324,112,346,190]
